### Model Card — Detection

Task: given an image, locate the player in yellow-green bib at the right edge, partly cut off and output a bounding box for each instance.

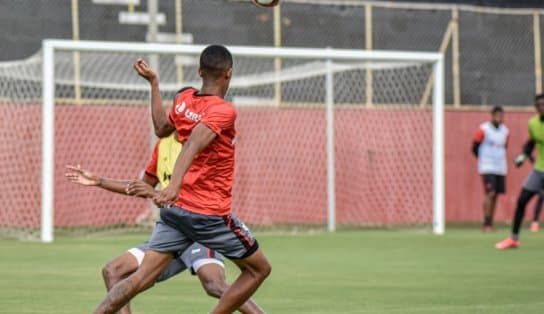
[495,94,544,250]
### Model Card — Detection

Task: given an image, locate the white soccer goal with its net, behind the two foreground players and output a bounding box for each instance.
[0,41,443,241]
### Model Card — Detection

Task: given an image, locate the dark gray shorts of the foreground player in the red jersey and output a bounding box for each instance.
[149,206,259,259]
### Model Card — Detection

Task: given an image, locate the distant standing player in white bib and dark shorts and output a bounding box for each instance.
[472,106,508,231]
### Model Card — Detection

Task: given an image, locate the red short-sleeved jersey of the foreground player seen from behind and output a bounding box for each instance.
[168,88,236,216]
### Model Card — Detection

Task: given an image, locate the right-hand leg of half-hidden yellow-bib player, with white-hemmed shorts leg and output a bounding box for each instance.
[180,242,264,314]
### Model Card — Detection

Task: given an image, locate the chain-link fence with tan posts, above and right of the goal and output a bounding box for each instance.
[0,0,544,106]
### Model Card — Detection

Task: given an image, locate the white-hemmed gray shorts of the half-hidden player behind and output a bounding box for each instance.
[128,242,225,282]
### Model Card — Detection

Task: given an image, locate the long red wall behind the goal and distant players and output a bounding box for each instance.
[0,104,532,227]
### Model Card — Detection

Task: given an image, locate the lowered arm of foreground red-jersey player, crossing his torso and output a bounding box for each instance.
[153,123,217,204]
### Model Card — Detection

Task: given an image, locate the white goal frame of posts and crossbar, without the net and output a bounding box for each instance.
[41,39,445,242]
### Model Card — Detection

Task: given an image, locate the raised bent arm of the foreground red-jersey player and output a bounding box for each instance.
[134,58,174,137]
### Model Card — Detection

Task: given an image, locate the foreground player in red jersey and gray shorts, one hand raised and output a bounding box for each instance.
[95,45,272,314]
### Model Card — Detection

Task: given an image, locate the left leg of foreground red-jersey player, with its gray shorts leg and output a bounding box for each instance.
[95,221,191,314]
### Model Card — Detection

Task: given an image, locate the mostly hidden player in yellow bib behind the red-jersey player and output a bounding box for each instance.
[66,133,264,314]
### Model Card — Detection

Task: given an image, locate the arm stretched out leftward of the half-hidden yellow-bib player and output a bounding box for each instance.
[65,165,157,197]
